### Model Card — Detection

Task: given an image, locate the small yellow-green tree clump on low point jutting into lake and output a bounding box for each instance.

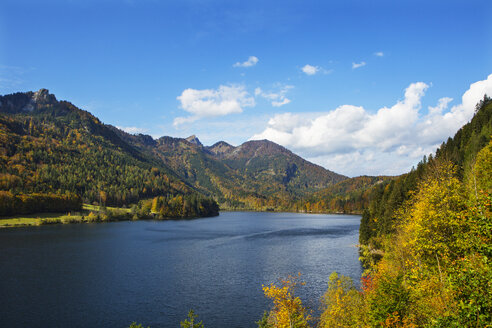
[136,194,219,219]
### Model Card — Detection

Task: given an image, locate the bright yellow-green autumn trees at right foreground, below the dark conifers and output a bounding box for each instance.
[298,157,492,327]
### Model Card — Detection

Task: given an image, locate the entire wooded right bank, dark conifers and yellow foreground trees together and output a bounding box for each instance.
[258,97,492,328]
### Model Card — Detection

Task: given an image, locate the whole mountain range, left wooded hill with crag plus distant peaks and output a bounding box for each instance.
[0,89,347,213]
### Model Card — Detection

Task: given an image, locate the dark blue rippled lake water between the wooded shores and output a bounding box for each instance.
[0,212,361,328]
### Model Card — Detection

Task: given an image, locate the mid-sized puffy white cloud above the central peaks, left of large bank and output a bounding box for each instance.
[173,85,255,126]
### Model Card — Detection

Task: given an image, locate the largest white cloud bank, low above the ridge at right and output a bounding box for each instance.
[251,74,492,176]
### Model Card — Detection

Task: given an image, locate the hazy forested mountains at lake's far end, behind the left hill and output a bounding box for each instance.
[113,116,347,211]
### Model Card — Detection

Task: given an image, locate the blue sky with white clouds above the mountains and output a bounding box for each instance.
[0,0,492,176]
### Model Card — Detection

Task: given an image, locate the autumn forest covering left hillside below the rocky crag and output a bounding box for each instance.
[0,97,192,206]
